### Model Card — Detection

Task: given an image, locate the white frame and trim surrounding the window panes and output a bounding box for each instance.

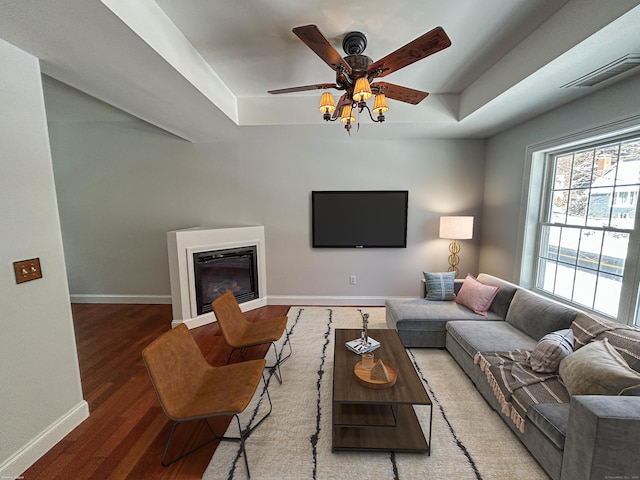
[518,123,640,325]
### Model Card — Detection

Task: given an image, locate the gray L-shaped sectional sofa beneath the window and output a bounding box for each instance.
[385,274,640,480]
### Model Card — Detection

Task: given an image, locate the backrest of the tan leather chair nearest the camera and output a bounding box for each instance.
[142,323,209,420]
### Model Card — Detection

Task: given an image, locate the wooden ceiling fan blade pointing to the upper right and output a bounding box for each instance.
[367,27,451,78]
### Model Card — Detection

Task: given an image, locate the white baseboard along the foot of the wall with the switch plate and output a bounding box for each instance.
[0,400,89,478]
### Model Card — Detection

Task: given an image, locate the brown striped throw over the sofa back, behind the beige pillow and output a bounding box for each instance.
[571,312,640,371]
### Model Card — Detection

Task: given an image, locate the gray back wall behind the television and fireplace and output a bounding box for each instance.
[46,80,485,301]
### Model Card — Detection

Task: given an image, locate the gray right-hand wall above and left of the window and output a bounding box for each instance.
[479,75,640,283]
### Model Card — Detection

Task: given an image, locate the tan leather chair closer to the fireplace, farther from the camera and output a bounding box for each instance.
[211,291,293,383]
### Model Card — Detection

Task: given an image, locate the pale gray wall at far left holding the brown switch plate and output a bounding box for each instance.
[0,39,88,478]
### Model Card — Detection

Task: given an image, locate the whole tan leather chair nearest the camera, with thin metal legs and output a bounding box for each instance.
[142,324,272,473]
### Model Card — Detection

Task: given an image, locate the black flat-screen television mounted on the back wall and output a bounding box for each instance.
[311,190,409,248]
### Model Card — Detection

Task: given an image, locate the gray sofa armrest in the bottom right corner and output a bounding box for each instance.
[561,395,640,480]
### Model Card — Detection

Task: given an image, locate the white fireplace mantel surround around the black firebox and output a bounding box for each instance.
[167,226,267,328]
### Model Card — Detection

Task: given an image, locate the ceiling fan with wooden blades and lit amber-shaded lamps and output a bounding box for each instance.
[268,25,451,132]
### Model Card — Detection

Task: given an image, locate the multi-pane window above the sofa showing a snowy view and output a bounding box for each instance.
[535,137,640,323]
